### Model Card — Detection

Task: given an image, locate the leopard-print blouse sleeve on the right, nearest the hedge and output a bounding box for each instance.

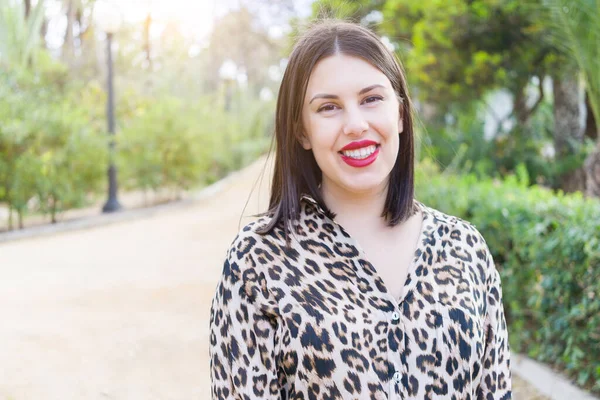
[477,250,512,400]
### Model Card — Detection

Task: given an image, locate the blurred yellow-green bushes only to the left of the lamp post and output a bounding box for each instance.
[0,67,107,226]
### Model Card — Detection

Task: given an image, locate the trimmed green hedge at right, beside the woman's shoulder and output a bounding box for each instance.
[416,161,600,393]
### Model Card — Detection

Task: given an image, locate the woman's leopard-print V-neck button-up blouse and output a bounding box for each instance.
[210,196,511,400]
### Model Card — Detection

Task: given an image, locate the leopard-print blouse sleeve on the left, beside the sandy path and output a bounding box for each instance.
[209,244,279,400]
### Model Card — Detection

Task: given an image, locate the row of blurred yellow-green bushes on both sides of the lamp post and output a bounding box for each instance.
[0,58,274,227]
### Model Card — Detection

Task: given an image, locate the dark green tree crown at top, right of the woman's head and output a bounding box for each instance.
[382,0,551,112]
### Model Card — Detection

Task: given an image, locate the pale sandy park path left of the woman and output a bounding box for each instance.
[0,159,542,400]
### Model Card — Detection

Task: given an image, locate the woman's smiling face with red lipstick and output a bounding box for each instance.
[302,55,403,195]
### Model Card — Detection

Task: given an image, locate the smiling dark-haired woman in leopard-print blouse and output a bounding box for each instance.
[210,21,511,400]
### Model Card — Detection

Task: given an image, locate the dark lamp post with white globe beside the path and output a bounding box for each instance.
[94,0,123,213]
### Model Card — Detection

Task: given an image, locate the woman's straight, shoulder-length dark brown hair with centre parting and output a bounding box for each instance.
[258,19,414,241]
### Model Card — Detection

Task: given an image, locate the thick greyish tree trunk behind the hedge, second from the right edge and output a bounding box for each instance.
[552,75,586,192]
